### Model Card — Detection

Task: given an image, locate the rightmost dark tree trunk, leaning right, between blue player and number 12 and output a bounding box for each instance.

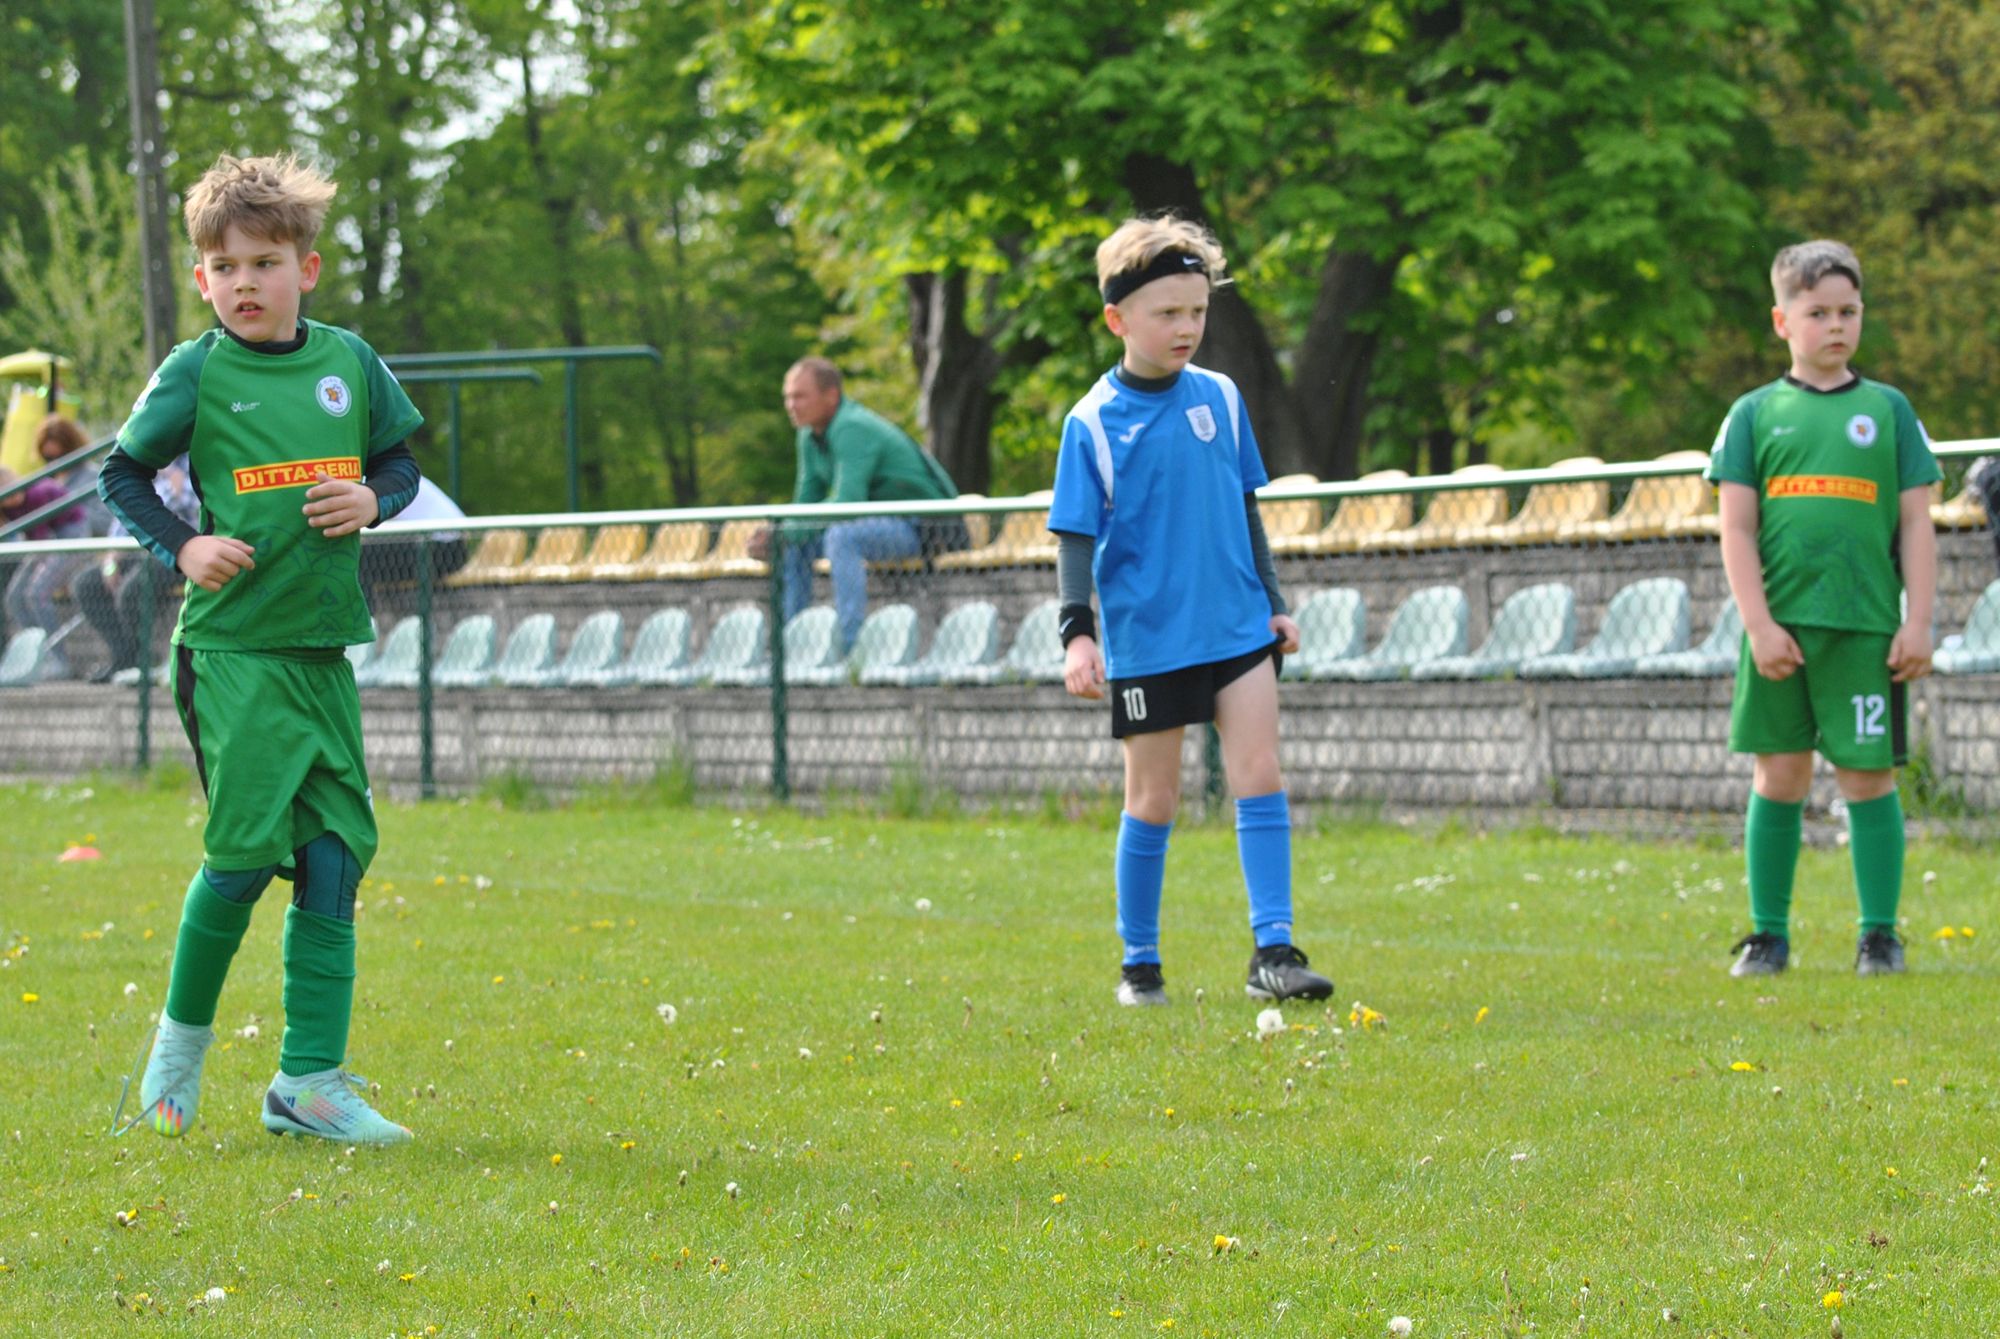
[1272,250,1398,480]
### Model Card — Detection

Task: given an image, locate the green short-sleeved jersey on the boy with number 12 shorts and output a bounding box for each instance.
[1706,378,1940,634]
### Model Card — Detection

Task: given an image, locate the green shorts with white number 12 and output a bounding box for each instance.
[1730,628,1910,771]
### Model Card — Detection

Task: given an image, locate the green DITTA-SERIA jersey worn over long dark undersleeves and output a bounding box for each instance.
[118,322,424,652]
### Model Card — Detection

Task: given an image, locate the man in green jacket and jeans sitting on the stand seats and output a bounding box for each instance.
[764,358,964,650]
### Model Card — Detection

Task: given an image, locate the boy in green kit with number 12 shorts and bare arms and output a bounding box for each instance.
[1708,242,1940,977]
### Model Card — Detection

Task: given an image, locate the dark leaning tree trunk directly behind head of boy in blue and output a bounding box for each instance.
[1124,154,1320,478]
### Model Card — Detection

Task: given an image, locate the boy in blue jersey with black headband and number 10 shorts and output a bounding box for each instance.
[1048,218,1334,1005]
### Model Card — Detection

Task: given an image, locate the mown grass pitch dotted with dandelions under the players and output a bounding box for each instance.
[0,779,2000,1339]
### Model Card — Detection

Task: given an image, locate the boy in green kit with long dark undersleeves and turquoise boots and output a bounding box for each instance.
[100,156,422,1143]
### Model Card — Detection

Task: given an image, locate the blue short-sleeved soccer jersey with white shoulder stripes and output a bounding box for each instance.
[1048,366,1274,679]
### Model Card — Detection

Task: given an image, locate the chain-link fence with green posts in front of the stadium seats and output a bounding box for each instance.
[11,442,2000,831]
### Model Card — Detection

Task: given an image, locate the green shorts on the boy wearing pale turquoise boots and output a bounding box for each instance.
[174,646,378,869]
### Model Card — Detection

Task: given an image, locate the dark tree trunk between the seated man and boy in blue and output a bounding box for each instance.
[904,270,1002,494]
